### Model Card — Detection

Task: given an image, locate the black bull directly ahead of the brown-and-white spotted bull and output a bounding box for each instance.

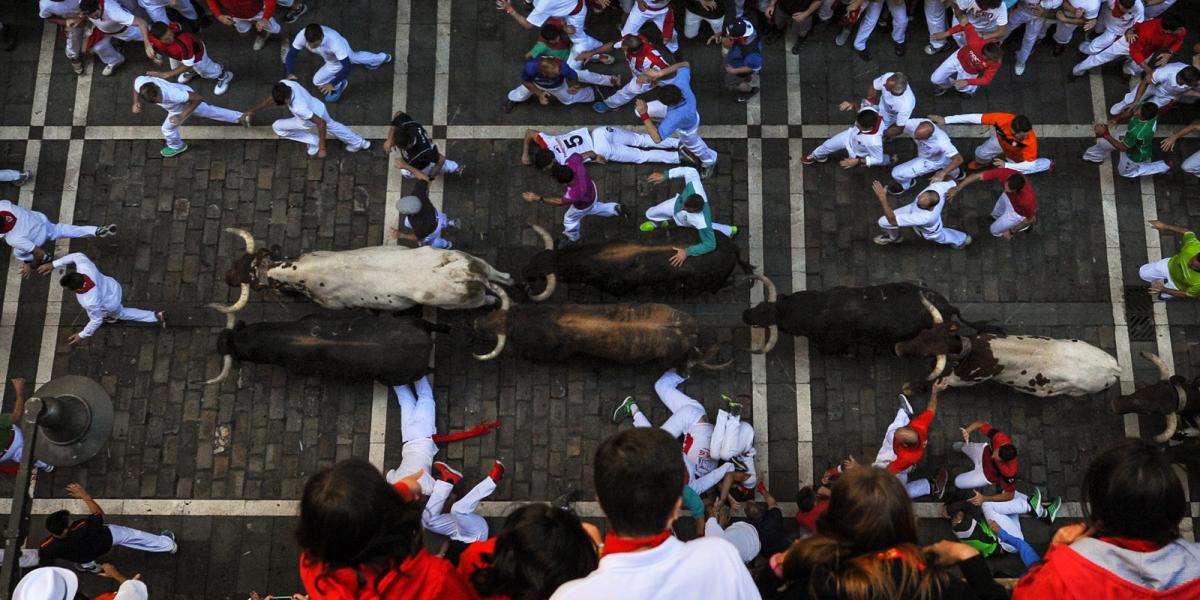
[742,275,984,354]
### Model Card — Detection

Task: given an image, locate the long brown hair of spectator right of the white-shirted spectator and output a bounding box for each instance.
[784,467,948,600]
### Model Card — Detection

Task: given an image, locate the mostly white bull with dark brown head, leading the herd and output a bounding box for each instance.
[220,227,512,312]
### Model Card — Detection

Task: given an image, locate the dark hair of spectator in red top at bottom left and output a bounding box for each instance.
[296,458,422,588]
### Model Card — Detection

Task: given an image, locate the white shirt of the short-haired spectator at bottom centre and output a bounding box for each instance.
[551,538,762,600]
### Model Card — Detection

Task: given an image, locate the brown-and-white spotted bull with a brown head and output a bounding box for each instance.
[895,296,1121,397]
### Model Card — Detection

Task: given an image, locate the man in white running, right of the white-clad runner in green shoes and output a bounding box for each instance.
[241,79,371,158]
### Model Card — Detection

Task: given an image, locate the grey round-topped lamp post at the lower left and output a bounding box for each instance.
[0,376,113,600]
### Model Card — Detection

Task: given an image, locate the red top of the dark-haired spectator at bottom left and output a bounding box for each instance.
[300,550,476,600]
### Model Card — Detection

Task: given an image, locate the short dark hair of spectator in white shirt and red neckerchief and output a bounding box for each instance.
[592,427,686,538]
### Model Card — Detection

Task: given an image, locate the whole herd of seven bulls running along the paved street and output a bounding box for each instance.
[206,223,1200,445]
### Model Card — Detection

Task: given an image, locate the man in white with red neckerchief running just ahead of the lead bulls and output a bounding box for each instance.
[37,252,167,346]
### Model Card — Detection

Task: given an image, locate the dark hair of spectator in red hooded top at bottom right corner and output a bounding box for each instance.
[1082,439,1187,544]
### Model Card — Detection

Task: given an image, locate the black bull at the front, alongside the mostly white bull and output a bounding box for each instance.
[205,313,448,385]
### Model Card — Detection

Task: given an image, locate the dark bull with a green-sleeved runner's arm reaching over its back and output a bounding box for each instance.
[522,222,754,302]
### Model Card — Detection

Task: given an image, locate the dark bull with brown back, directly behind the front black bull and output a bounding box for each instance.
[474,286,733,370]
